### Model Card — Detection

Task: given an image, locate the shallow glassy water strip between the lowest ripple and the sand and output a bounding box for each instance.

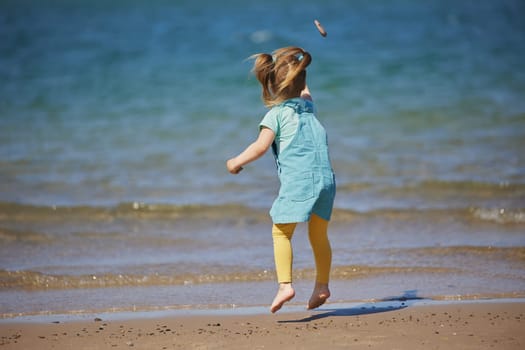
[0,274,525,322]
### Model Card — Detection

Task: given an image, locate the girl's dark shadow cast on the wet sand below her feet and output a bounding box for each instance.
[278,290,424,323]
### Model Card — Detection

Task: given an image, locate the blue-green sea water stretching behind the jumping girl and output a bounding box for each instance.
[0,0,525,314]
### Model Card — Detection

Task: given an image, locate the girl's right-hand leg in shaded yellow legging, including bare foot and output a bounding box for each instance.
[308,214,332,309]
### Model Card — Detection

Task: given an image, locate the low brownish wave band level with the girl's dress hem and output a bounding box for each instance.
[0,202,525,226]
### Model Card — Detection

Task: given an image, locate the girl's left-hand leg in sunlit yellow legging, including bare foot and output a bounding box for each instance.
[270,223,297,313]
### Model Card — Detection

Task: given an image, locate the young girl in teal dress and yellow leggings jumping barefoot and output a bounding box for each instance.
[226,47,335,313]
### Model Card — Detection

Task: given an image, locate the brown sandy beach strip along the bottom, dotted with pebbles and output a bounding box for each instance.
[0,300,525,350]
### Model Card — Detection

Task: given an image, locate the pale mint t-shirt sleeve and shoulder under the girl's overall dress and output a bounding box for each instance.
[259,97,313,154]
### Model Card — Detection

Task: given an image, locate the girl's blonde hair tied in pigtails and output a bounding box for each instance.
[250,46,312,107]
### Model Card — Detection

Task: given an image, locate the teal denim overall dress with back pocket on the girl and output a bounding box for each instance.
[270,98,336,224]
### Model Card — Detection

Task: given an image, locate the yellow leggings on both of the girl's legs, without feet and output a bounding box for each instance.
[272,214,332,283]
